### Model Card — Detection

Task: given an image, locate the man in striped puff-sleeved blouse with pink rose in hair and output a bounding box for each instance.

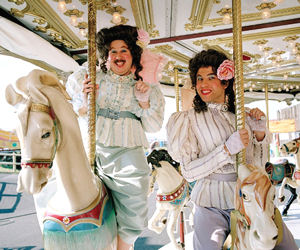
[167,49,298,250]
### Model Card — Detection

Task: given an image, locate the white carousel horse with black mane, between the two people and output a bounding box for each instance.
[147,149,190,249]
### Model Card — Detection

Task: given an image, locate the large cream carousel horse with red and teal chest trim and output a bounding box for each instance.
[6,70,117,250]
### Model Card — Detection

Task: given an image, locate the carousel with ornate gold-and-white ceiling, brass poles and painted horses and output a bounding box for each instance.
[0,0,300,250]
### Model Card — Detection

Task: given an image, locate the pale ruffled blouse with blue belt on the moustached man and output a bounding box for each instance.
[66,67,165,148]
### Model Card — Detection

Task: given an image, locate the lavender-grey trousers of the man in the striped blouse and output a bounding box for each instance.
[193,206,298,250]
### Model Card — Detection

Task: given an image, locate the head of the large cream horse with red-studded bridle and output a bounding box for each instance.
[6,70,68,194]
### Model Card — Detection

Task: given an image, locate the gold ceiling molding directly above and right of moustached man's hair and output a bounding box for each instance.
[130,0,159,38]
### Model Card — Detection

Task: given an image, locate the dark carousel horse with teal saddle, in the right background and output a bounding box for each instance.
[265,159,297,216]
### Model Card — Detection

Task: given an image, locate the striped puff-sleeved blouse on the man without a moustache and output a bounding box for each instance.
[167,103,271,209]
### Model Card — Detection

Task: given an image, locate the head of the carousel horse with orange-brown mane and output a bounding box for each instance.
[235,165,278,249]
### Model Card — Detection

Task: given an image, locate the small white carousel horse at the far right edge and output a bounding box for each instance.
[278,137,300,206]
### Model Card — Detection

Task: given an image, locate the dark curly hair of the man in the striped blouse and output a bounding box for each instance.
[189,49,235,113]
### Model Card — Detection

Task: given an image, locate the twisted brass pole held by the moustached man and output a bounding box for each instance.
[87,0,97,169]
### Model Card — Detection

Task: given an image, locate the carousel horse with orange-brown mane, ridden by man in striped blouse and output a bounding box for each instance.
[231,165,282,250]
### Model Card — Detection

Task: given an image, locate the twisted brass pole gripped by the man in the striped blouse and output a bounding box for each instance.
[232,0,246,166]
